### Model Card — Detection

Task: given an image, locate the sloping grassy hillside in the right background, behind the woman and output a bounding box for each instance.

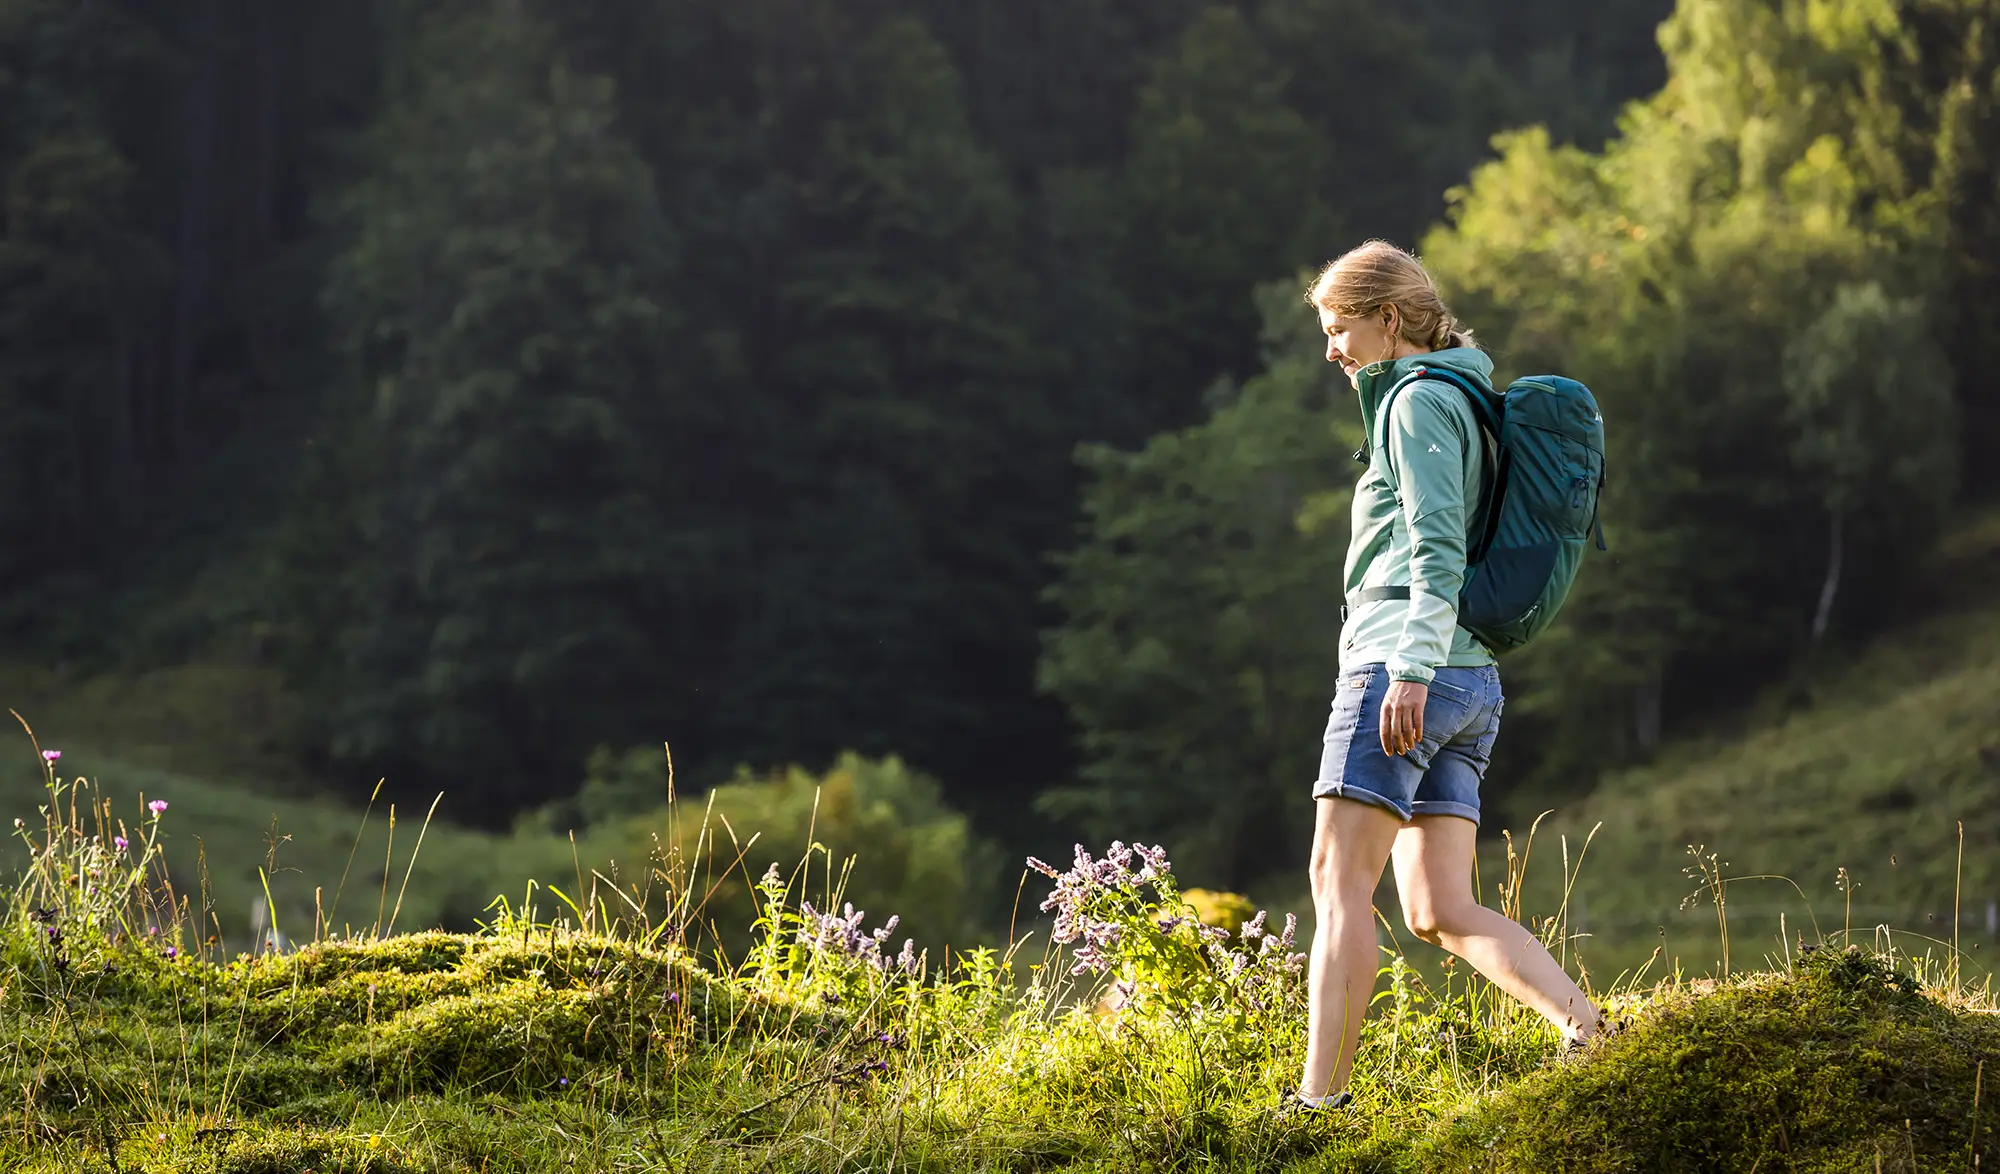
[1516,516,2000,988]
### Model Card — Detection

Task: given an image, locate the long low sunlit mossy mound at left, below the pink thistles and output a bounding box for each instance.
[0,934,736,1116]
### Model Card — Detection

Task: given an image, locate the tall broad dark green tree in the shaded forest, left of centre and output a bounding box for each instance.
[298,16,698,804]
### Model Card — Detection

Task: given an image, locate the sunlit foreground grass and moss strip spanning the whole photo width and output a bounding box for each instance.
[0,832,2000,1174]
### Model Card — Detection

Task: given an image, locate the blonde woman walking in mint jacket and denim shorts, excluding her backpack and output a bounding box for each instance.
[1292,240,1602,1108]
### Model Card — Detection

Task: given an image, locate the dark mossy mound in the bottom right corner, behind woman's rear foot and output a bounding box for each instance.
[1372,950,2000,1174]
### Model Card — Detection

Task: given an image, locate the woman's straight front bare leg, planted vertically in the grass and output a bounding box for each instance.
[1298,798,1402,1096]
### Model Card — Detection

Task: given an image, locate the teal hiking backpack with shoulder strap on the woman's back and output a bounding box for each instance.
[1376,368,1604,656]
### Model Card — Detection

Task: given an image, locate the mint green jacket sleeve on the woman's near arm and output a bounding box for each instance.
[1386,382,1472,684]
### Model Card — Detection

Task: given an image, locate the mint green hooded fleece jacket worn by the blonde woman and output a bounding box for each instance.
[1340,346,1494,684]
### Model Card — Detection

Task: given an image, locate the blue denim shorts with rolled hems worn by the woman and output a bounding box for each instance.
[1312,664,1504,824]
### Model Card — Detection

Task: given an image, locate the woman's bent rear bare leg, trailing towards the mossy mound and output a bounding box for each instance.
[1394,816,1600,1040]
